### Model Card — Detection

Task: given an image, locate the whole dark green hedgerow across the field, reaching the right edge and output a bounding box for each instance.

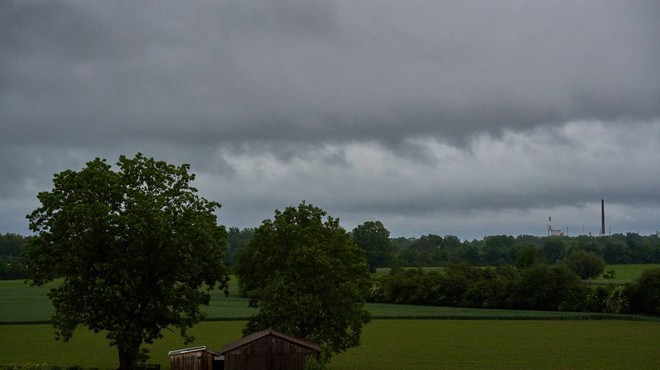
[369,263,660,314]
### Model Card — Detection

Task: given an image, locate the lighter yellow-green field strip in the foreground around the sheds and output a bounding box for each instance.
[0,320,660,370]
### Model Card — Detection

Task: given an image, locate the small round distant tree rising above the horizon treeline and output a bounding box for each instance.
[351,221,394,272]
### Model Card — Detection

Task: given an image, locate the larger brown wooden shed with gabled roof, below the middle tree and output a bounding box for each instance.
[220,329,321,370]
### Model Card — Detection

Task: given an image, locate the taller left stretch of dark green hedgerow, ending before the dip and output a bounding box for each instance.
[370,263,587,311]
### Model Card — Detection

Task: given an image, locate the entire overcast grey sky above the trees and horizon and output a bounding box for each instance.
[0,0,660,240]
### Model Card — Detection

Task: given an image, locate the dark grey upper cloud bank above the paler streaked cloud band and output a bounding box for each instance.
[2,1,660,147]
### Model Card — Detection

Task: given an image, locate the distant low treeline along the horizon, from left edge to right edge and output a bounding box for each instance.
[5,227,660,279]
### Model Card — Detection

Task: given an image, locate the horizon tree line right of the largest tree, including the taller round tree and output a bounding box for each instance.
[225,221,660,272]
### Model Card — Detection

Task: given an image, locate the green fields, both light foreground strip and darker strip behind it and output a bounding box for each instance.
[0,265,660,369]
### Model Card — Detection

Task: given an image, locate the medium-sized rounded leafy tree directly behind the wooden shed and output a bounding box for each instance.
[236,202,371,361]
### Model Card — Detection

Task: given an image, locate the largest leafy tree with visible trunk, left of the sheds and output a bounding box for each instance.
[26,154,228,369]
